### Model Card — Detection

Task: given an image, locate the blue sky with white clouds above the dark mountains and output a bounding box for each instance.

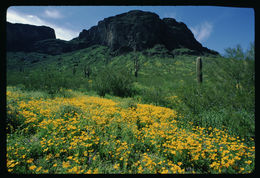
[6,6,255,54]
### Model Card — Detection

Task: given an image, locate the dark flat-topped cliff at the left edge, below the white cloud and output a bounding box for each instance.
[6,22,56,52]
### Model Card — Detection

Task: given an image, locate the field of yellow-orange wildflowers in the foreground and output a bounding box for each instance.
[6,87,255,174]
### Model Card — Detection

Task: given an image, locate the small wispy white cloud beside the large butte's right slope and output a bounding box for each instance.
[190,22,213,42]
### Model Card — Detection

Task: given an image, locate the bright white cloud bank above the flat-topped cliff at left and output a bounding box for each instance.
[6,9,79,40]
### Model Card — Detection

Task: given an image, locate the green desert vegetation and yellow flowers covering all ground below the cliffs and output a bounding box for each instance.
[6,41,255,174]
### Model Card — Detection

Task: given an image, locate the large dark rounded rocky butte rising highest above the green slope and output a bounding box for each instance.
[7,10,218,54]
